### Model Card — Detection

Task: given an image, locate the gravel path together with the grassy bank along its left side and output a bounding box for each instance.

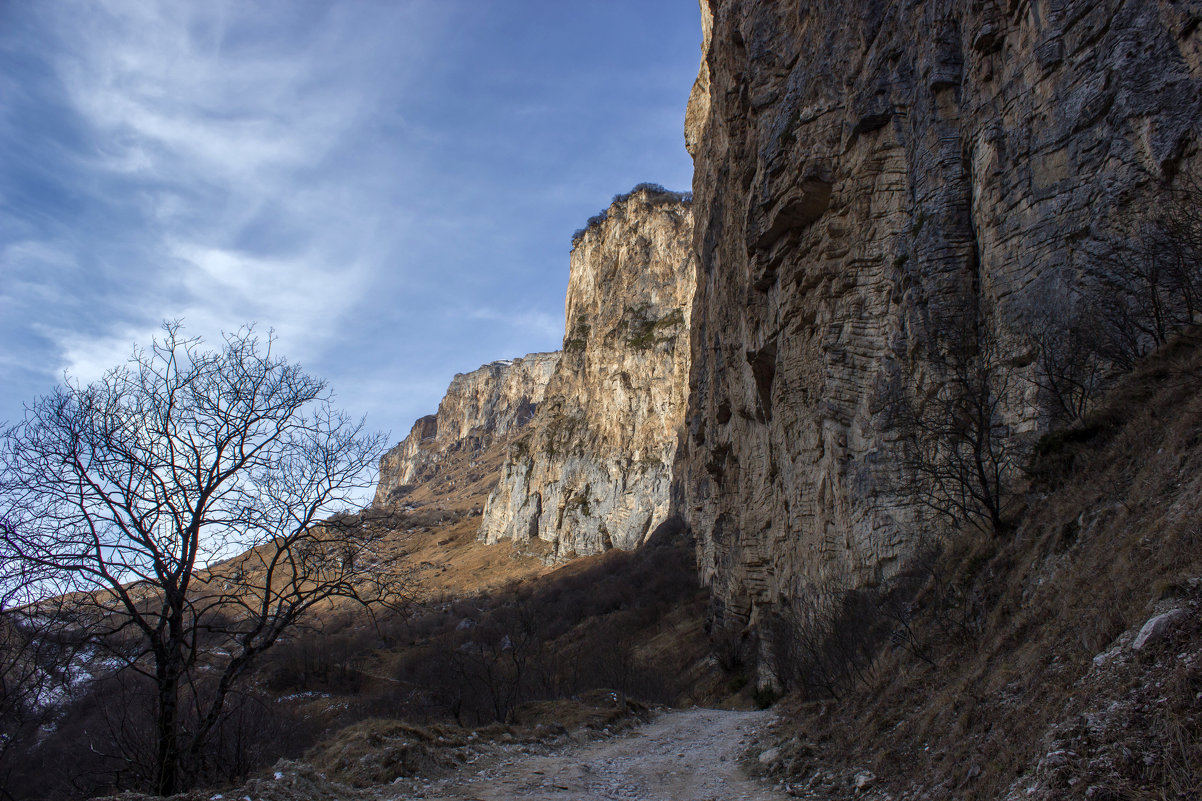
[96,707,786,801]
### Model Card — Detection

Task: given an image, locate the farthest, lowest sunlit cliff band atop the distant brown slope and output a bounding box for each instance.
[373,354,559,508]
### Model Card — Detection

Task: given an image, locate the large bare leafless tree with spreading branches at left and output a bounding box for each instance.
[0,324,401,795]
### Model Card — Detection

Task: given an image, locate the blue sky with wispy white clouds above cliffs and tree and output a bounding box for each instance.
[0,0,701,449]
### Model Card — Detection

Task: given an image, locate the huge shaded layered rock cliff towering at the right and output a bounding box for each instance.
[674,0,1202,625]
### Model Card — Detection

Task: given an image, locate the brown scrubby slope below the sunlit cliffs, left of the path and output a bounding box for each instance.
[6,430,716,799]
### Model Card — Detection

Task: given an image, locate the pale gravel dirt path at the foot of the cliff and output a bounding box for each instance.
[396,710,784,801]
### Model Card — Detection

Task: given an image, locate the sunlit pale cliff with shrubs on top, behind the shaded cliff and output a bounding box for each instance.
[480,190,694,558]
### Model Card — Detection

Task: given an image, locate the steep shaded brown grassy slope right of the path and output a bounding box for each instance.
[754,331,1202,800]
